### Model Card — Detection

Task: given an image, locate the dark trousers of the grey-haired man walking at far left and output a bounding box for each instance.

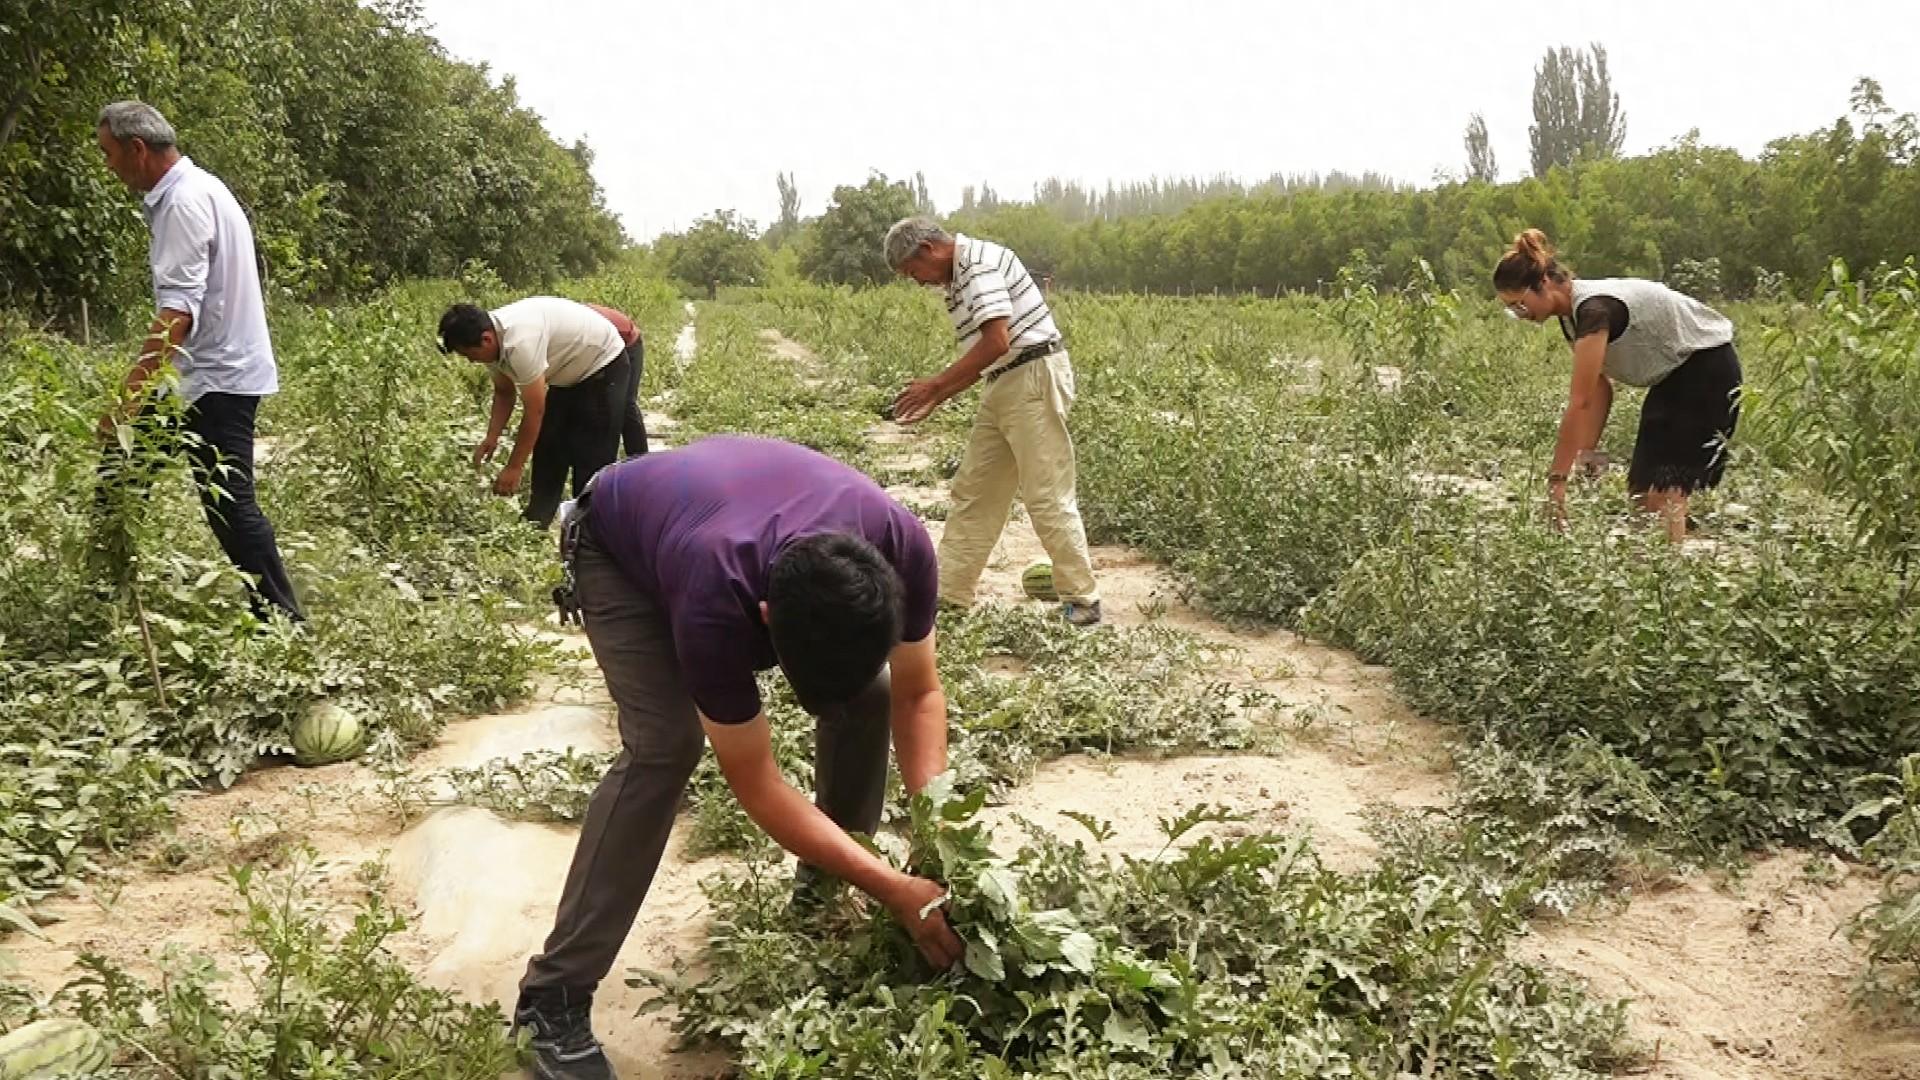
[100,394,305,623]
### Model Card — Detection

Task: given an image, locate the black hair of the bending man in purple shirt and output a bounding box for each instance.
[766,532,906,711]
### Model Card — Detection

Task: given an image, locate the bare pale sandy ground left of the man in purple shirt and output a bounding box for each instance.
[6,306,728,1080]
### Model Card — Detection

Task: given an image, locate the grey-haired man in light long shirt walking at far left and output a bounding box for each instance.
[96,102,301,621]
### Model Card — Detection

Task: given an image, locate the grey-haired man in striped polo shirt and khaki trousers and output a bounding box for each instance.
[885,217,1100,626]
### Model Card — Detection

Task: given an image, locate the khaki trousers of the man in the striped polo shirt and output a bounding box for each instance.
[941,352,1100,607]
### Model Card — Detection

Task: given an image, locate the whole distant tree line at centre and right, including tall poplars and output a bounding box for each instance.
[657,76,1920,298]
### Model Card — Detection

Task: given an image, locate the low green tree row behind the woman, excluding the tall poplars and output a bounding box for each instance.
[950,81,1920,294]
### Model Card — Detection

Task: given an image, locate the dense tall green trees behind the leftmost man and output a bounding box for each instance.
[0,0,626,315]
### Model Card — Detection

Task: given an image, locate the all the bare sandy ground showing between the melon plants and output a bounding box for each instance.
[8,321,1920,1080]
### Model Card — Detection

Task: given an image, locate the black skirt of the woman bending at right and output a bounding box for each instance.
[1626,342,1740,494]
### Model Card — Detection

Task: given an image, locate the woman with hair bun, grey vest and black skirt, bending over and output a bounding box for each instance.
[1494,229,1740,540]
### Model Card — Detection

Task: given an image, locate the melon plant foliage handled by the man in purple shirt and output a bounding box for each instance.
[630,774,1622,1080]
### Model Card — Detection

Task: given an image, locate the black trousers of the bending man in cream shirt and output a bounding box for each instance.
[526,350,645,528]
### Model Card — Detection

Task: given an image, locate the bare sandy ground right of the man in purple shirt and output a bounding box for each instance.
[762,331,1920,1080]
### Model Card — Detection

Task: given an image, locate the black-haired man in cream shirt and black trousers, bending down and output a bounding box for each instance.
[440,296,634,528]
